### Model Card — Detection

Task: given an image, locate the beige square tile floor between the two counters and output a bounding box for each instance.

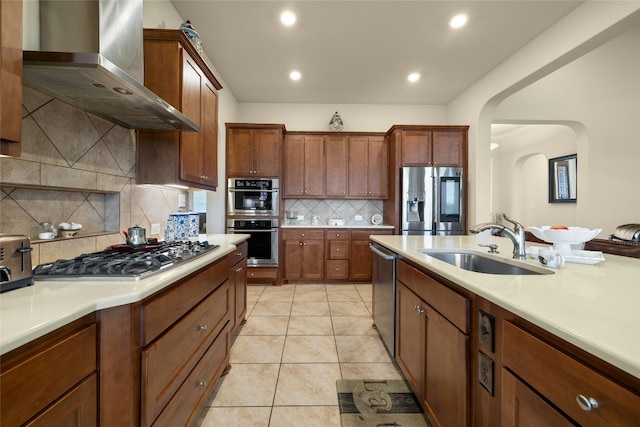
[201,284,401,427]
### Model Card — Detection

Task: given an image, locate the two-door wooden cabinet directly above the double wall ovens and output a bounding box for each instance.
[226,123,285,178]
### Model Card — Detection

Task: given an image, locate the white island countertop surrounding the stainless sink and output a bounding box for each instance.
[372,235,640,378]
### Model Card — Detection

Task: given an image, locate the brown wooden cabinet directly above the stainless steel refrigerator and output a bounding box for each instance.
[389,126,468,167]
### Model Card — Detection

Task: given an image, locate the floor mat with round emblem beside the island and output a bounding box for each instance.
[336,380,430,427]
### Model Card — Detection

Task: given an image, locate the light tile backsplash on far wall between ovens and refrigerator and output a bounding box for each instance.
[284,199,382,225]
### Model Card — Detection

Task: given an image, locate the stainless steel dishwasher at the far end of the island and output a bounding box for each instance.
[369,243,396,357]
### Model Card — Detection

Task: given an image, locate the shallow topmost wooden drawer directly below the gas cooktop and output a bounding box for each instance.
[141,261,230,345]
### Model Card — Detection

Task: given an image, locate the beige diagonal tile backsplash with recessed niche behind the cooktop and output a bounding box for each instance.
[0,86,188,266]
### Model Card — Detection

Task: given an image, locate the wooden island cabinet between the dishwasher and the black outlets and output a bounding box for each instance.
[396,260,471,426]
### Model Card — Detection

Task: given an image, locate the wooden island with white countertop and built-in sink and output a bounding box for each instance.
[371,235,640,425]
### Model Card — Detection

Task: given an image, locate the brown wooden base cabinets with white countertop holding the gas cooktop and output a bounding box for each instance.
[0,234,248,425]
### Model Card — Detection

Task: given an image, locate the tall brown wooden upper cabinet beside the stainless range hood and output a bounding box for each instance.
[137,29,222,190]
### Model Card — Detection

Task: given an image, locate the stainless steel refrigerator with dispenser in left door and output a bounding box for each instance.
[400,167,465,235]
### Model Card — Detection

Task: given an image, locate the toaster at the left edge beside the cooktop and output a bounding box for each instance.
[0,234,34,292]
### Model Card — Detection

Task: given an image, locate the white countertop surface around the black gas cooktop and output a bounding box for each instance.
[0,234,249,354]
